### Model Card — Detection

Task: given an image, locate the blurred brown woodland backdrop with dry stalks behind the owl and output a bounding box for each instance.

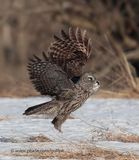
[0,0,139,97]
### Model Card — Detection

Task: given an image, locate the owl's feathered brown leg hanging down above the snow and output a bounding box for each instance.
[52,114,69,132]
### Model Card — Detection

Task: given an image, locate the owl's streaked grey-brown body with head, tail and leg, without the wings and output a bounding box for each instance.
[24,65,100,131]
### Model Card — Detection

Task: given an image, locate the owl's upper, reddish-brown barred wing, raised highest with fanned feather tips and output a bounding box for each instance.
[48,28,91,78]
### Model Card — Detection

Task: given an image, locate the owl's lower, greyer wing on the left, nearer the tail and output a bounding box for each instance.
[28,54,74,96]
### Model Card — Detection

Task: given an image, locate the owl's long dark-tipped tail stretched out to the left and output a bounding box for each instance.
[23,100,60,116]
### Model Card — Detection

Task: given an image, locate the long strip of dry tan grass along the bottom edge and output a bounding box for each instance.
[13,147,139,160]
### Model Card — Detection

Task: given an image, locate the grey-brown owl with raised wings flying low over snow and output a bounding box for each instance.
[24,28,100,131]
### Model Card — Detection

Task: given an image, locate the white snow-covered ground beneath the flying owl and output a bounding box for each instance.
[0,97,139,159]
